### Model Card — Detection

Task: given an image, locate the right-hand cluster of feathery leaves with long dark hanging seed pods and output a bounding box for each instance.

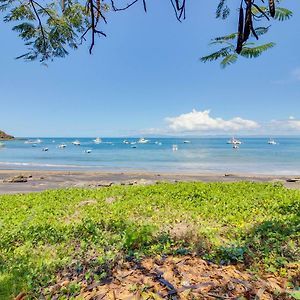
[201,0,293,68]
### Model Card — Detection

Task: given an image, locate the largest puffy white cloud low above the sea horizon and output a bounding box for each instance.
[166,109,260,132]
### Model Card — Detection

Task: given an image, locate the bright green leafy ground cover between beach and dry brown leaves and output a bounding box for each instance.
[0,182,300,299]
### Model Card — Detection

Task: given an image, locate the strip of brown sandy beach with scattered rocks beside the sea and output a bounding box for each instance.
[0,169,300,195]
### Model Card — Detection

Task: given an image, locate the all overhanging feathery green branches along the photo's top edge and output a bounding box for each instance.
[0,0,292,67]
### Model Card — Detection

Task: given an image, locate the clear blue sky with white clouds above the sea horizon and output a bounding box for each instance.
[0,0,300,137]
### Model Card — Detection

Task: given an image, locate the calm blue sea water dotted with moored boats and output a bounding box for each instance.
[0,138,300,175]
